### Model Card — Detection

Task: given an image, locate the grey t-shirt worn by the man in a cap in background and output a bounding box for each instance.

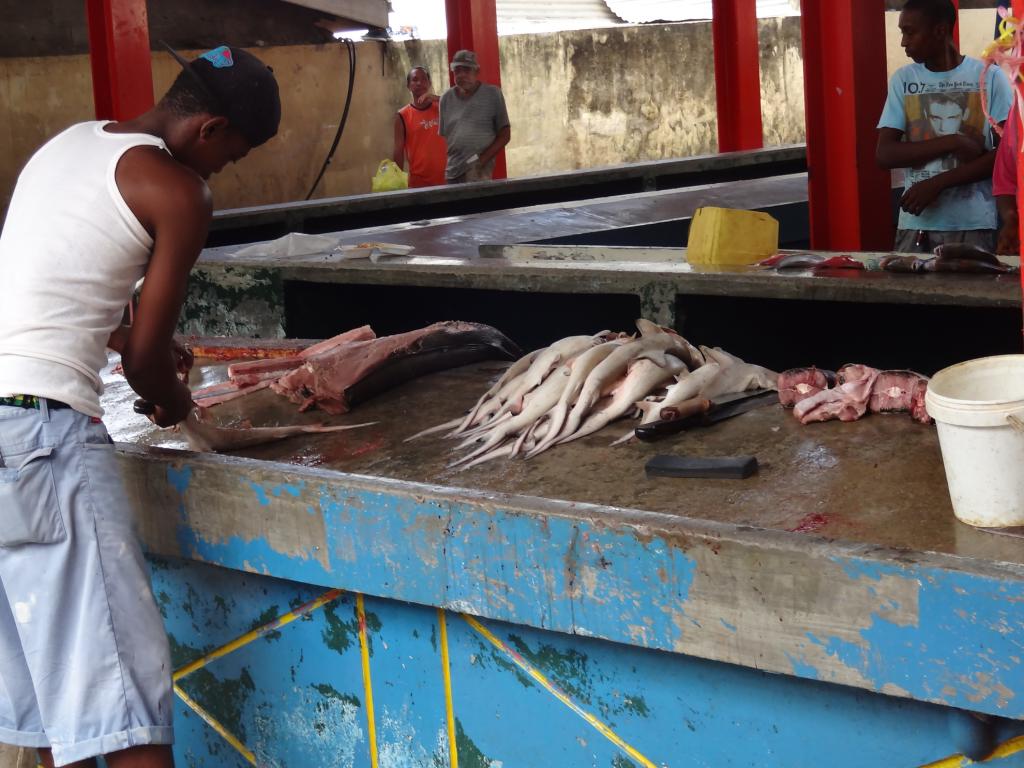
[438,83,509,178]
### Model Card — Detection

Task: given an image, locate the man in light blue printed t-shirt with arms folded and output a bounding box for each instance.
[877,0,1013,252]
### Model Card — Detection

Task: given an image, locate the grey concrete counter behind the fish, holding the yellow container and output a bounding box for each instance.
[188,174,1021,348]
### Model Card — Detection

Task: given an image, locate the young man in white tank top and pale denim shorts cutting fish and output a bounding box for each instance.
[0,46,281,768]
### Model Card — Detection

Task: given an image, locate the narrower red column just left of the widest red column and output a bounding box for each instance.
[712,0,764,152]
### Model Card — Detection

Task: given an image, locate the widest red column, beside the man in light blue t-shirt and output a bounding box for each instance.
[801,0,893,251]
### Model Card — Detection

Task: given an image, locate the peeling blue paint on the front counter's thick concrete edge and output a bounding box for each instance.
[159,467,1024,729]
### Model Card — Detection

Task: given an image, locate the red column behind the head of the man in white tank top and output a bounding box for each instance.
[85,0,153,120]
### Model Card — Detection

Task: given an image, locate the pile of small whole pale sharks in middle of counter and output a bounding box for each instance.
[408,319,777,469]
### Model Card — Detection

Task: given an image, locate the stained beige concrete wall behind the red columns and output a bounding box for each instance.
[0,10,1007,217]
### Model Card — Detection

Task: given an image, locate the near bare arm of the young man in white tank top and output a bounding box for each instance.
[116,147,213,426]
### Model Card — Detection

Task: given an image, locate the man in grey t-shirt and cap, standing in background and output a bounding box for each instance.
[438,50,512,184]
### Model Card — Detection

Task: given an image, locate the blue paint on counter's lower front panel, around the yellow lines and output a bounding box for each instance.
[154,561,1024,768]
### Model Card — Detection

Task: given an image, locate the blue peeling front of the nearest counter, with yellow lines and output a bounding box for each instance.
[122,449,1024,768]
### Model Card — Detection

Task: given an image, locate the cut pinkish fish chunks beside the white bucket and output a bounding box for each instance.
[779,365,931,424]
